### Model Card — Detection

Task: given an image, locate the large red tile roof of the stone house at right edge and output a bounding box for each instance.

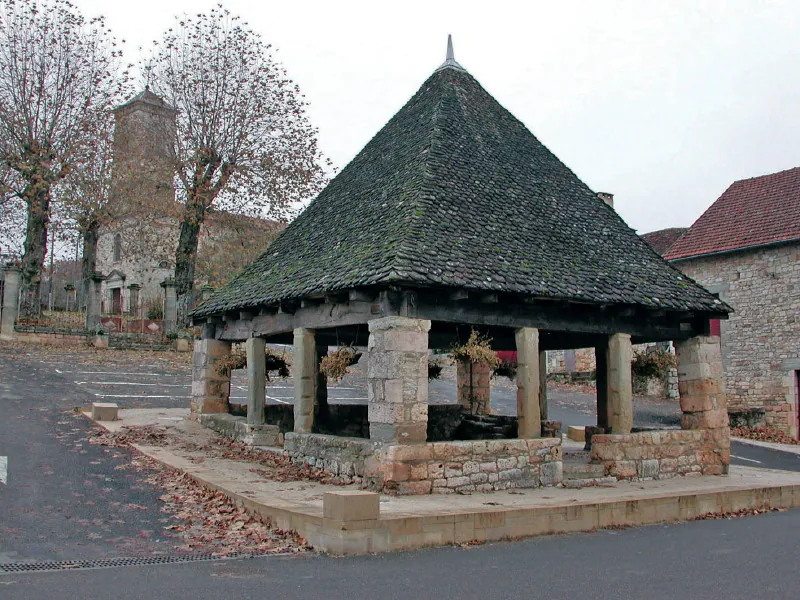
[664,167,800,260]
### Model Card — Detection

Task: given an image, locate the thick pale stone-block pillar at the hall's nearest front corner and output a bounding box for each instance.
[367,317,431,444]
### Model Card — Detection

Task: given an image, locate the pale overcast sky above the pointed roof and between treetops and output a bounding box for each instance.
[75,0,800,233]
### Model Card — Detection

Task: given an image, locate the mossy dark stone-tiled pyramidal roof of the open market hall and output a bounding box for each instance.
[195,59,728,317]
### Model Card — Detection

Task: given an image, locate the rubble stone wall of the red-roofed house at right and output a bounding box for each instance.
[674,244,800,436]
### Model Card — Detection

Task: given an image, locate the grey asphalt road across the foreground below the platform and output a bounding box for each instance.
[0,510,800,600]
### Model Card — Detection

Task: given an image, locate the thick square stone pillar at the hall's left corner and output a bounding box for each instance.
[191,338,231,419]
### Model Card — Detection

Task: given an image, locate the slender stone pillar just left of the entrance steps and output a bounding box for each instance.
[515,327,542,439]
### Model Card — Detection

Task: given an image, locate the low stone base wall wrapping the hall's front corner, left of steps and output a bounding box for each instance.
[284,433,562,495]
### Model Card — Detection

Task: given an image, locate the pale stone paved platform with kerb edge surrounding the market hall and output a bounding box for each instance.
[86,409,800,554]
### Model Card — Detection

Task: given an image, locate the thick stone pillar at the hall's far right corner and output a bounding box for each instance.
[675,336,728,429]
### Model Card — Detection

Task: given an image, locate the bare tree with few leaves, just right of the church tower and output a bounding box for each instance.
[144,5,325,322]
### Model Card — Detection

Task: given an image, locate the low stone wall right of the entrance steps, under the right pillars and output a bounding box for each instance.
[590,428,730,480]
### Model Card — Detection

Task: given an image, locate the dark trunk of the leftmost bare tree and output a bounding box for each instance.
[20,178,50,317]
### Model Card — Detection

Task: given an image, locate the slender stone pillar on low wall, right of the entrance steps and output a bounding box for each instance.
[606,333,633,433]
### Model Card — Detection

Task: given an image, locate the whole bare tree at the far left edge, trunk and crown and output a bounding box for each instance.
[0,0,123,315]
